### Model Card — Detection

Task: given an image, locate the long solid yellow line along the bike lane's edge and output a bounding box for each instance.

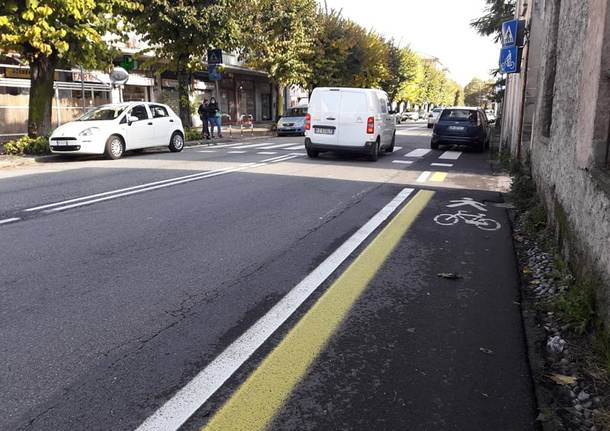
[202,190,434,431]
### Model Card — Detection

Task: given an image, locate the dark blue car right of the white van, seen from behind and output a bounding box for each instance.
[430,107,490,152]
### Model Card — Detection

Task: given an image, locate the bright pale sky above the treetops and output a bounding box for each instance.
[318,0,500,85]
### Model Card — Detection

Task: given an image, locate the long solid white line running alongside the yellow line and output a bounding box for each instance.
[136,189,413,431]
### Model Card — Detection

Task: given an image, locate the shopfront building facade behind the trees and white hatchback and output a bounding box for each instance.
[0,41,277,140]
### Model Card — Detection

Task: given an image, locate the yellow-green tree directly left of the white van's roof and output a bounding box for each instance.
[242,0,317,115]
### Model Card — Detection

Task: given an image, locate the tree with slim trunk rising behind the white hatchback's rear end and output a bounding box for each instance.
[130,0,242,126]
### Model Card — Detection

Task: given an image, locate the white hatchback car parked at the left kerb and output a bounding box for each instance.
[49,102,184,159]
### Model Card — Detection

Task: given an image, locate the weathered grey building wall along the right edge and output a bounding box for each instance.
[502,0,610,327]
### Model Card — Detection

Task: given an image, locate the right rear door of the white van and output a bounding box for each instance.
[337,90,372,147]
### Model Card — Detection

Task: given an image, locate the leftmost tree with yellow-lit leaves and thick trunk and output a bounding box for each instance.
[0,0,141,137]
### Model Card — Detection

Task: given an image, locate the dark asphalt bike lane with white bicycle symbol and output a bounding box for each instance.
[192,186,536,431]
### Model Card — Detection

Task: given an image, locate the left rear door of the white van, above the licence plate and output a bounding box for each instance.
[309,89,342,145]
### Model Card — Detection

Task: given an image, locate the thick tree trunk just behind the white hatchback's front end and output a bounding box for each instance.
[28,56,57,138]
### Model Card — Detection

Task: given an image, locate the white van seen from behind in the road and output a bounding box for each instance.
[305,87,396,161]
